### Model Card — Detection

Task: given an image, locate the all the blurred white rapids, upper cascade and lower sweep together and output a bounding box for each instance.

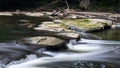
[7,39,120,68]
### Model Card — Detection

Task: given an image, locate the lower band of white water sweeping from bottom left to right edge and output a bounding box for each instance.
[7,49,120,68]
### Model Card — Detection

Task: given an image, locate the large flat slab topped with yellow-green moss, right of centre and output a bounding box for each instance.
[54,19,113,32]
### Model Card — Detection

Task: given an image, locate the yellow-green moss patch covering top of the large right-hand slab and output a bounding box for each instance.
[63,19,104,30]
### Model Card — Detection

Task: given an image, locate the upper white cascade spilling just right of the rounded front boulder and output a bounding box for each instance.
[67,39,117,52]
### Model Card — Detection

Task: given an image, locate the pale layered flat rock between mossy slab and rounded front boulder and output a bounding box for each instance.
[34,22,80,41]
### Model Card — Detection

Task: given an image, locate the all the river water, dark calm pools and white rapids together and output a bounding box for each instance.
[0,16,120,68]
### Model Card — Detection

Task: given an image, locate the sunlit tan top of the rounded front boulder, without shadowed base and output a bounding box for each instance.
[22,36,67,46]
